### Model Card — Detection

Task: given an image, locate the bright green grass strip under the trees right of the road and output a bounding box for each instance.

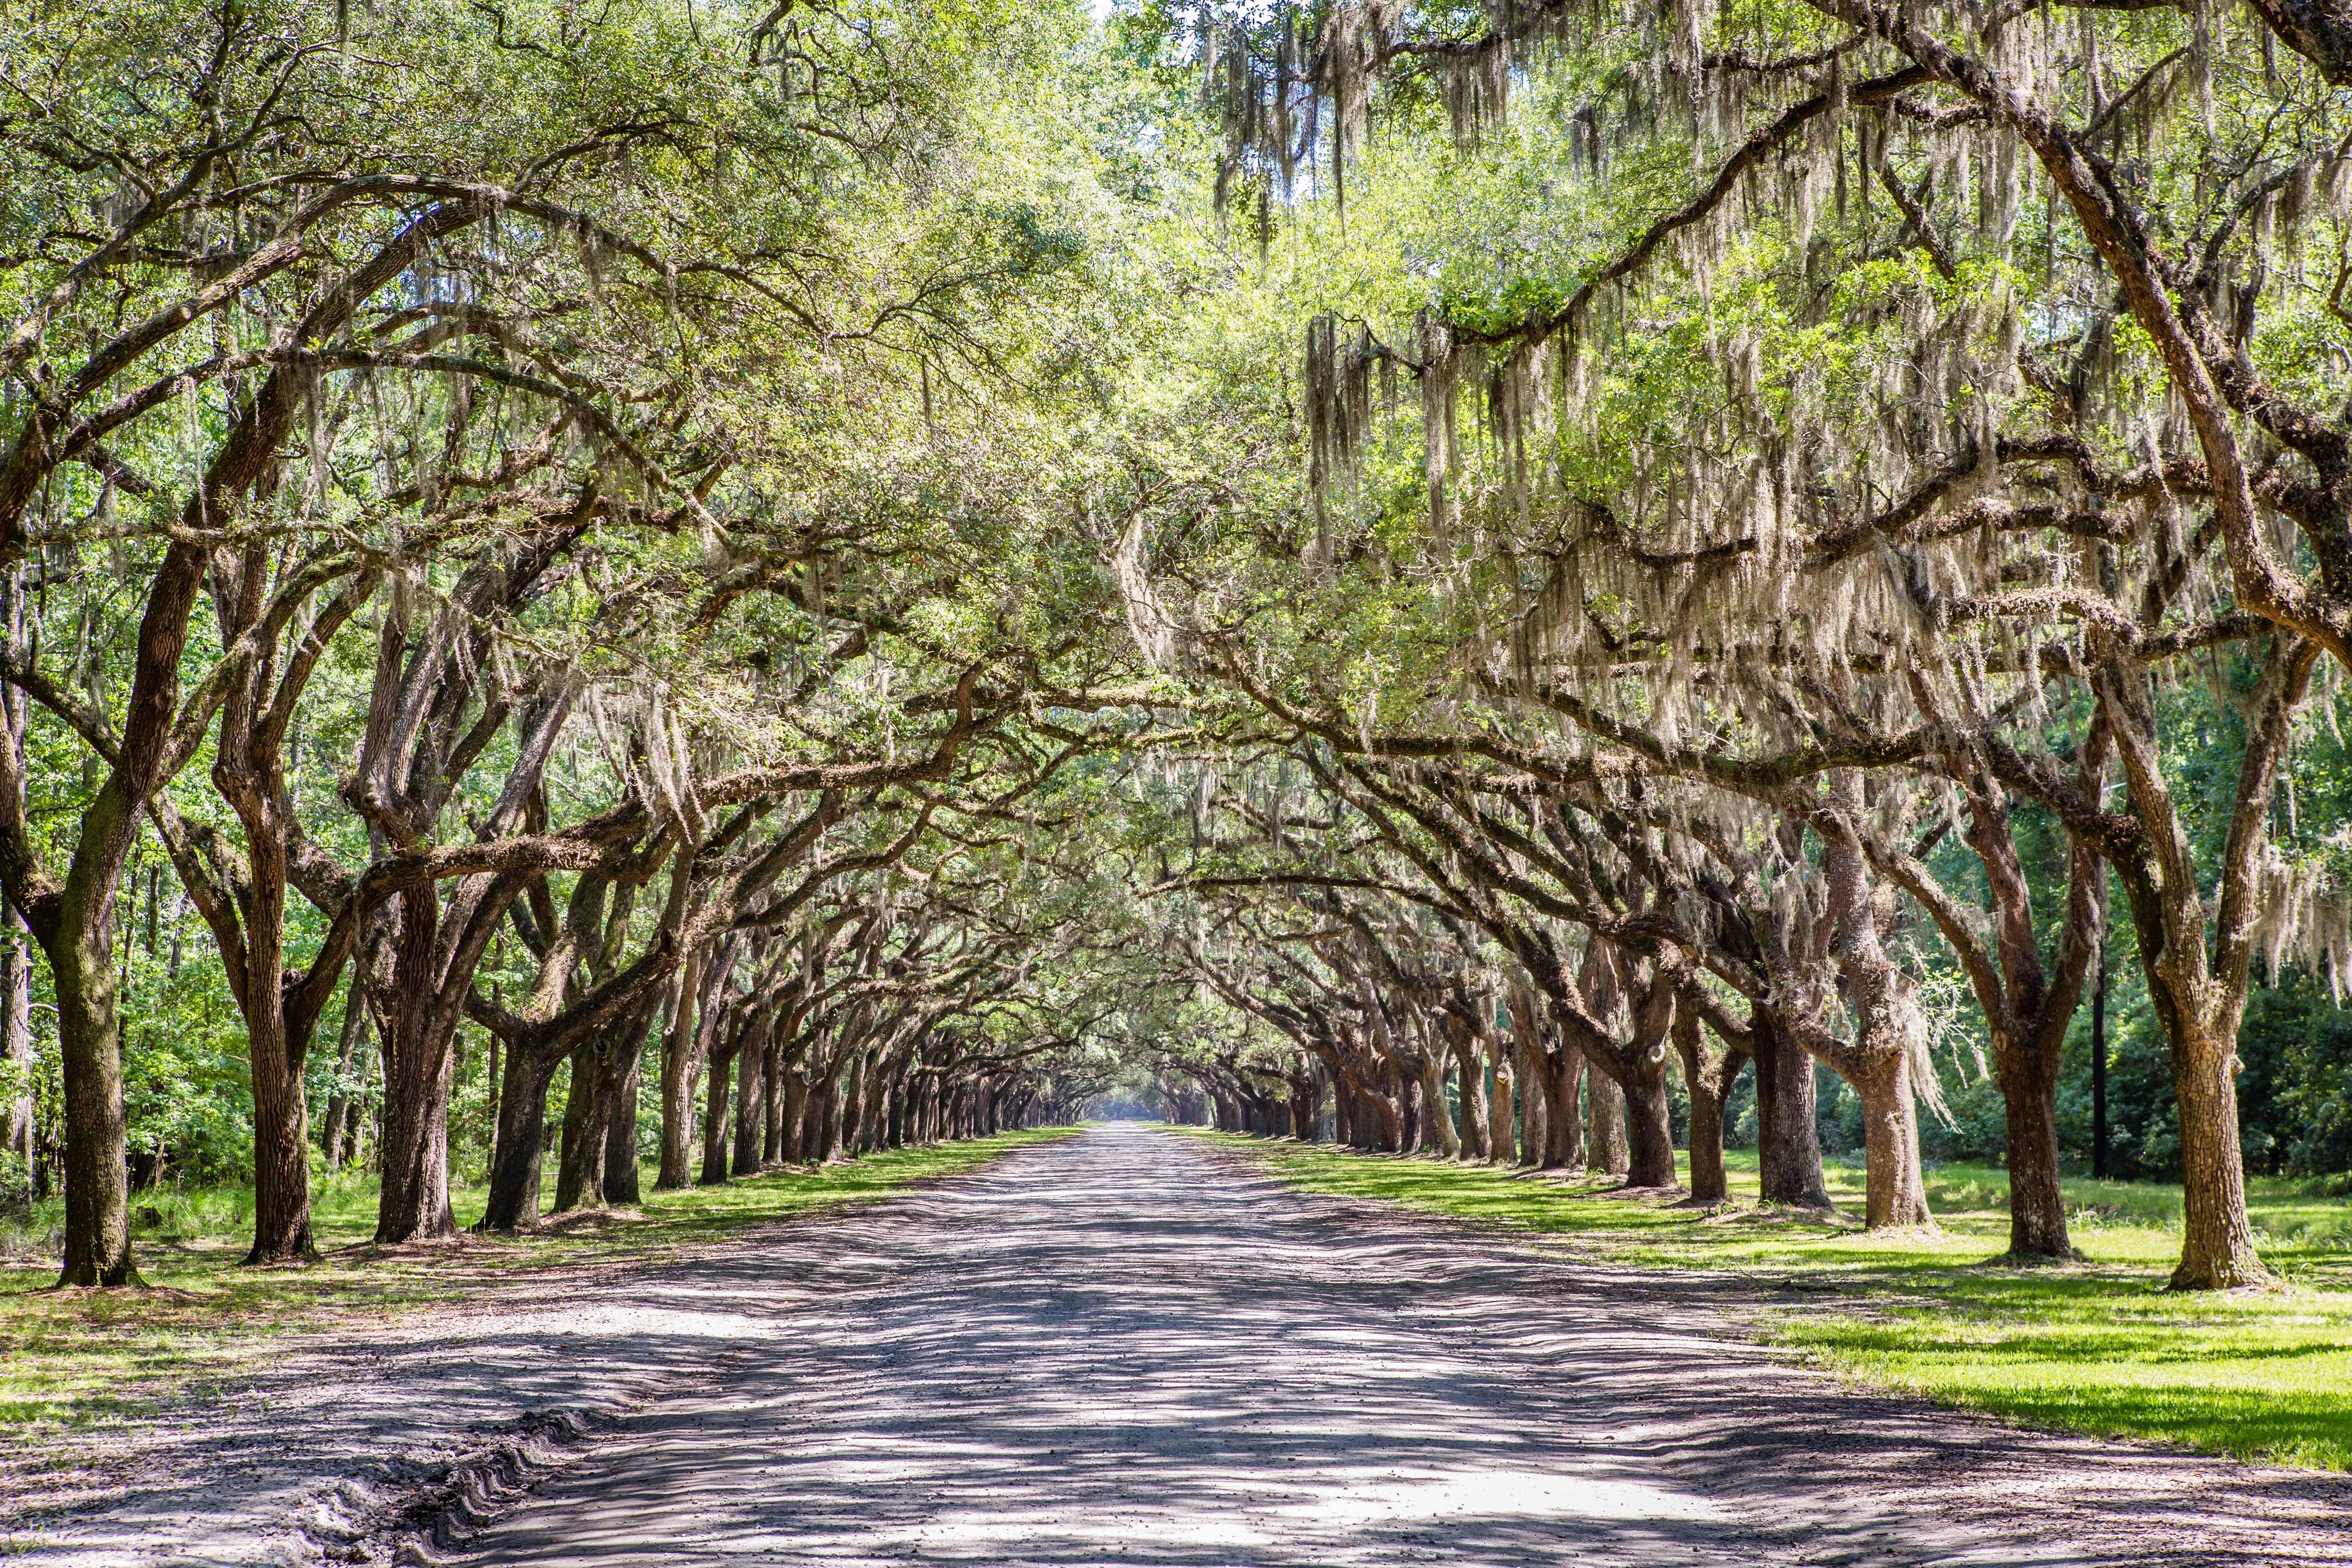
[1181,1128,2352,1469]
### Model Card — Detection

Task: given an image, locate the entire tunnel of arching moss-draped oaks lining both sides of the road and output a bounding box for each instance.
[0,0,2352,1288]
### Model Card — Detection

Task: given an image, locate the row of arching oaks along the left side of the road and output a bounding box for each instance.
[0,0,1138,1286]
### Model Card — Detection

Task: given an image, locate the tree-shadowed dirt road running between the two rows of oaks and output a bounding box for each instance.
[23,1126,2352,1568]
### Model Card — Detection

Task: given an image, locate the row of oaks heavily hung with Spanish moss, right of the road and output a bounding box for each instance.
[1101,0,2352,1288]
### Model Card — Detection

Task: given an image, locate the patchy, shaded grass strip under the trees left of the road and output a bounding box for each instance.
[0,1128,1075,1448]
